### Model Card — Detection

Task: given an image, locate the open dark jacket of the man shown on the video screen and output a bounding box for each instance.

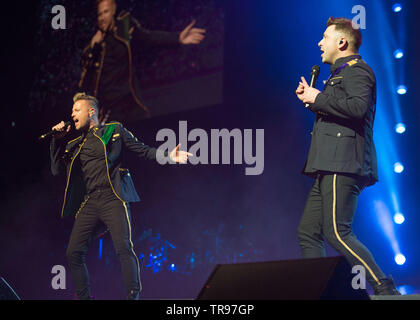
[78,11,179,112]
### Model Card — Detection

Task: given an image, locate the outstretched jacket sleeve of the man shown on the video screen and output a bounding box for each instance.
[130,15,180,46]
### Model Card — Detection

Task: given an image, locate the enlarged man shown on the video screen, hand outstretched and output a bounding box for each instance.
[78,0,205,122]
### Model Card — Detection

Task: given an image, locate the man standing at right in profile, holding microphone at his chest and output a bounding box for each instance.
[296,17,399,295]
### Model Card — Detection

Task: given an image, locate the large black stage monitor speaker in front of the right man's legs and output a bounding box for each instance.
[197,256,369,300]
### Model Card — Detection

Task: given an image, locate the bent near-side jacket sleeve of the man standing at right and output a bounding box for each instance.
[310,65,375,119]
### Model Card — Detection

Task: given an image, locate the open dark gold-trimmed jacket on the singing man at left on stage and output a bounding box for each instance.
[50,122,165,217]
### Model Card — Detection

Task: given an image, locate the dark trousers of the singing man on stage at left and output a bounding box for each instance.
[66,189,141,299]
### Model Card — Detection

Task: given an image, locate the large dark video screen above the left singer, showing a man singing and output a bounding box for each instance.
[30,0,224,122]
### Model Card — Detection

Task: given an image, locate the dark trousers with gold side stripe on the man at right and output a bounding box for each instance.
[298,173,385,287]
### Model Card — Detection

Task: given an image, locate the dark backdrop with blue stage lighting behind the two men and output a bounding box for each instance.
[0,0,420,299]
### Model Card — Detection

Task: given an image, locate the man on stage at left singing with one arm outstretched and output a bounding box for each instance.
[50,93,192,299]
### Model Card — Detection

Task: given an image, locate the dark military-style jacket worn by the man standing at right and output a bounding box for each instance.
[303,55,378,185]
